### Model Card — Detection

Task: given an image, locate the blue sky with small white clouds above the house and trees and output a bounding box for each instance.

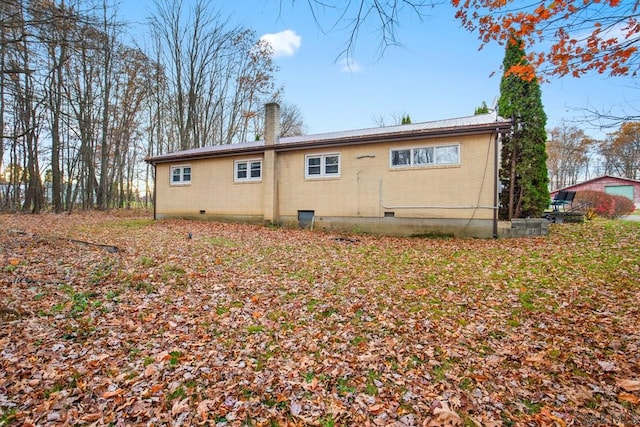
[119,0,640,138]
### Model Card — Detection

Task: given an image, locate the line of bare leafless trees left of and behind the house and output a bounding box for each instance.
[0,0,292,212]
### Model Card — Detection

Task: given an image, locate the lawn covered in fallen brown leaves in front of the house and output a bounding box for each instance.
[0,213,640,427]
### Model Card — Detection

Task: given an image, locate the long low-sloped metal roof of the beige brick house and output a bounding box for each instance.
[146,113,511,164]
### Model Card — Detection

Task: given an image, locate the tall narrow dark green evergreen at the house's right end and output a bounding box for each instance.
[498,38,549,220]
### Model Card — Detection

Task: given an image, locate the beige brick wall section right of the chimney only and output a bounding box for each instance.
[278,135,494,219]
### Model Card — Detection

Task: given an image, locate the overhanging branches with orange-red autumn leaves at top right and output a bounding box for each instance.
[452,0,640,78]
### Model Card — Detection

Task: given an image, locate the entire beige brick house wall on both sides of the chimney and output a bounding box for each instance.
[156,134,495,219]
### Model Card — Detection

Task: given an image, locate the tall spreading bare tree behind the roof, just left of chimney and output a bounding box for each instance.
[151,0,275,150]
